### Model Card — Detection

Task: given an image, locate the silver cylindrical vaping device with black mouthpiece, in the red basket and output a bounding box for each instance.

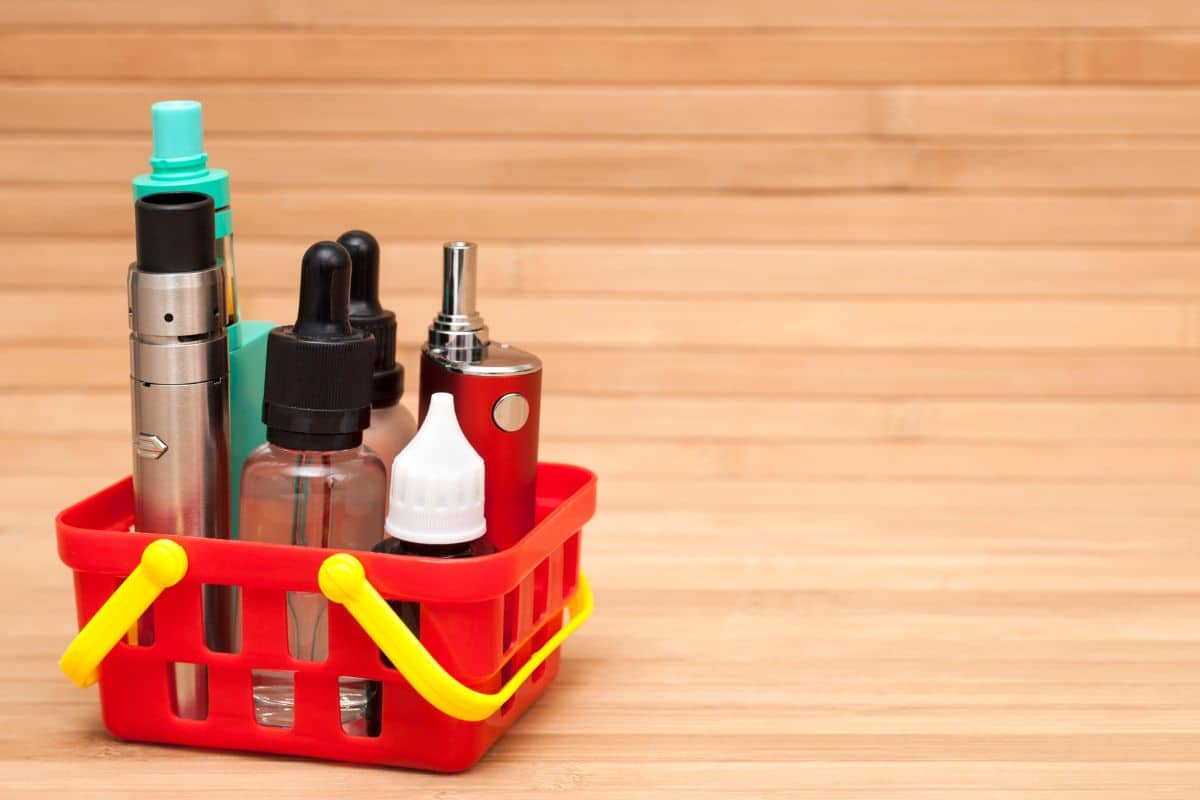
[128,192,232,720]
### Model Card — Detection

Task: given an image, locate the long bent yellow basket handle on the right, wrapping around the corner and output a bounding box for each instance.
[318,553,592,722]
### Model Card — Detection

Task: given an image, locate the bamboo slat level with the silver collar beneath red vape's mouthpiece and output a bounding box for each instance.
[14,290,1200,350]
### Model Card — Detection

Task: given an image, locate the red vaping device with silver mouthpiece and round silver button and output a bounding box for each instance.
[420,241,541,549]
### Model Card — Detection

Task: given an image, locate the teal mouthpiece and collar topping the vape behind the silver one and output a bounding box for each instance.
[133,100,233,226]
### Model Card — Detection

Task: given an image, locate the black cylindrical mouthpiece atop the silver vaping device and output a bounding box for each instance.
[133,192,217,272]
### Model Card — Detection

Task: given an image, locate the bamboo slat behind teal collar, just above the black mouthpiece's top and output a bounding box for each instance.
[21,133,1200,193]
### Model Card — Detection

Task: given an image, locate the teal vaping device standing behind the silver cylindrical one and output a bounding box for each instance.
[133,100,275,537]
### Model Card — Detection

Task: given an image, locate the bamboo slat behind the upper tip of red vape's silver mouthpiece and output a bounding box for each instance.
[9,236,1200,299]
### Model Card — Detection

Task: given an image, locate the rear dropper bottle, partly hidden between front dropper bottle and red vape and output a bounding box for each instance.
[337,230,416,476]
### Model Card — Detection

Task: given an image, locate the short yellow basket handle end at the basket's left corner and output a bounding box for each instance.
[59,539,187,687]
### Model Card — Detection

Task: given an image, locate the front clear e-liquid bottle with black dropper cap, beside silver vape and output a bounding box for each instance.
[234,237,386,733]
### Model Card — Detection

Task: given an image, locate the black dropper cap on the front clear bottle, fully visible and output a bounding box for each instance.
[263,241,374,451]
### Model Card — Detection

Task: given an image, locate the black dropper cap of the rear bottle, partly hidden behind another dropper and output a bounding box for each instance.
[337,230,404,408]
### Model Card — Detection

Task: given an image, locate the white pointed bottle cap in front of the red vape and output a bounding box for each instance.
[384,392,487,545]
